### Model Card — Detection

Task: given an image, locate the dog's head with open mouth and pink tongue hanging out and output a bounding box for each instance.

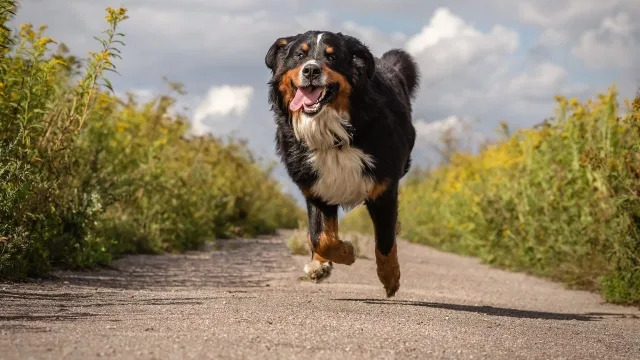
[265,31,375,117]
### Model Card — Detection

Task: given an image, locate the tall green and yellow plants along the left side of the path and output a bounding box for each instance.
[0,0,300,278]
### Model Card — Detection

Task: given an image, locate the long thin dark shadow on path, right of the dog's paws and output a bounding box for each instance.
[332,299,640,321]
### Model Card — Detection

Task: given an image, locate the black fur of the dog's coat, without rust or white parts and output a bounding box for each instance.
[265,31,419,262]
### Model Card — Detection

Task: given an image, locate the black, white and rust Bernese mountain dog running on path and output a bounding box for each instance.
[265,31,419,296]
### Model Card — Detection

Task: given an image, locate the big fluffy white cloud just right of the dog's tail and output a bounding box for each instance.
[406,8,518,116]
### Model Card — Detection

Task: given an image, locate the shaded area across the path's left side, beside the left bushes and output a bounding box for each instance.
[0,238,288,330]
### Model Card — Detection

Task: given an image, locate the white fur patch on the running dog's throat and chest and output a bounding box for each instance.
[293,107,374,207]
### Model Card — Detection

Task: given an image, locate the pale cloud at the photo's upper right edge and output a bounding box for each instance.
[572,13,640,69]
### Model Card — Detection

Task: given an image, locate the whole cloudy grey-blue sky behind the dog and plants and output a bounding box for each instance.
[15,0,640,192]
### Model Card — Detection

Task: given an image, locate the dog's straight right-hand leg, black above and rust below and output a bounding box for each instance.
[367,183,400,297]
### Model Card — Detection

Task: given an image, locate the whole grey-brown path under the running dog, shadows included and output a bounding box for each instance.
[0,232,640,359]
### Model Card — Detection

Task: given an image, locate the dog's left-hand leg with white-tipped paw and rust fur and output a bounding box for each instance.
[304,200,356,282]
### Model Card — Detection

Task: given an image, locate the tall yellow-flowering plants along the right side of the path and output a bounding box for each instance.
[345,90,640,303]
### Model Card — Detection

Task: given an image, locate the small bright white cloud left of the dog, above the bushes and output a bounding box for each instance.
[192,85,253,135]
